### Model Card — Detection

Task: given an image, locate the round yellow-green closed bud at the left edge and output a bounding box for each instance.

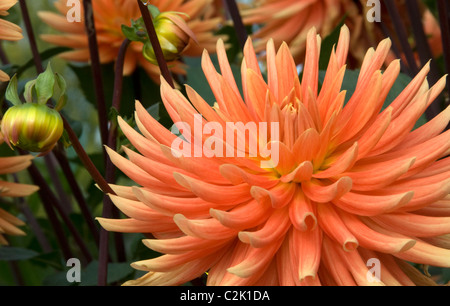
[1,103,64,153]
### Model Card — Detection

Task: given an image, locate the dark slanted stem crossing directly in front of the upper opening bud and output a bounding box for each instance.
[137,0,175,88]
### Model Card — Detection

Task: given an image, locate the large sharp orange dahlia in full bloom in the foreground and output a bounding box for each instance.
[99,26,450,285]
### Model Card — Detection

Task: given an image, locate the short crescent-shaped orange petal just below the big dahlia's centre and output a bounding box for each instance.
[302,176,352,203]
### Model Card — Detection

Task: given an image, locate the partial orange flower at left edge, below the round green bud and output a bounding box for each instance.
[0,155,38,245]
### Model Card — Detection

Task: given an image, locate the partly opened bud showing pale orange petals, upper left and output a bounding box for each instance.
[142,12,196,65]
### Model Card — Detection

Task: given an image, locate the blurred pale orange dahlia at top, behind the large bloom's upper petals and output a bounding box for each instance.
[241,0,367,64]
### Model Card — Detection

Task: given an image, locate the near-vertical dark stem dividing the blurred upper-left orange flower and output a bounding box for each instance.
[83,0,108,151]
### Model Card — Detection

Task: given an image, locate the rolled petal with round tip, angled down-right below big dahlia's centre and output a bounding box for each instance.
[317,203,359,252]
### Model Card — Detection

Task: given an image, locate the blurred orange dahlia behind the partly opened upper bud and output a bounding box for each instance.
[38,0,225,82]
